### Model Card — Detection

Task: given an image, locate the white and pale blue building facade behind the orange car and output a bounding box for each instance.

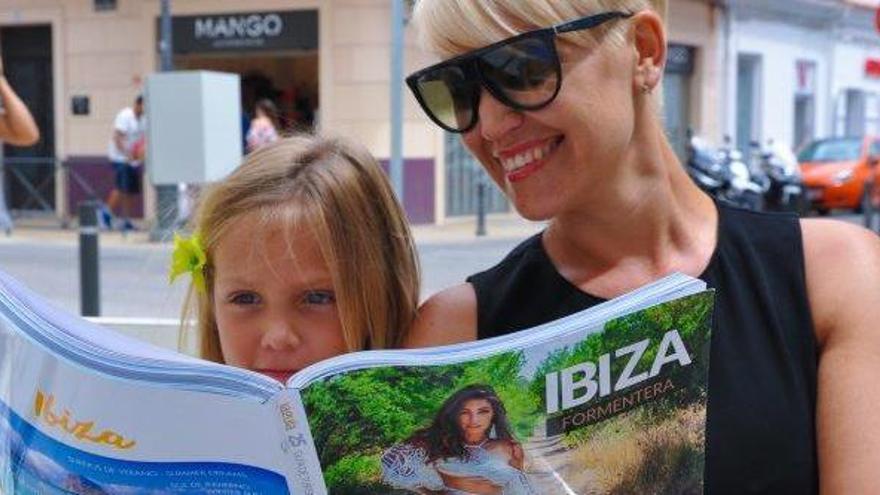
[724,0,880,150]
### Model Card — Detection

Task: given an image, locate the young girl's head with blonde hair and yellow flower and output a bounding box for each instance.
[171,136,419,381]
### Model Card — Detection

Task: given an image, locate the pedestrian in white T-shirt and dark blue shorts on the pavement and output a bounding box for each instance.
[101,95,145,231]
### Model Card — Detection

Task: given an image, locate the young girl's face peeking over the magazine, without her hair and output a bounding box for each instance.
[213,216,346,381]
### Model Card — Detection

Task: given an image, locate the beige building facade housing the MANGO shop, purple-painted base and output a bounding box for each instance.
[0,0,442,223]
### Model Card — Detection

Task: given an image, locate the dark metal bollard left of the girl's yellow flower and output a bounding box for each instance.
[79,201,101,316]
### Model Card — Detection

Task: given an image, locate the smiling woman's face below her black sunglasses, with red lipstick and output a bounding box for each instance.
[462,30,636,220]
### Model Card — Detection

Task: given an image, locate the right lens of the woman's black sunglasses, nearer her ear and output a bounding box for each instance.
[479,37,560,109]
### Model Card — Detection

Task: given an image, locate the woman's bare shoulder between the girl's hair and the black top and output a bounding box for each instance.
[404,283,477,347]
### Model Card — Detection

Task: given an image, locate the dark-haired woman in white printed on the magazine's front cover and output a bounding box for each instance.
[382,385,535,495]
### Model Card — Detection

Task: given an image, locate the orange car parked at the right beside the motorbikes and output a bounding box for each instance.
[798,136,880,214]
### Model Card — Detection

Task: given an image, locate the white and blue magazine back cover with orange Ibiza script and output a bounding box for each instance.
[0,315,300,495]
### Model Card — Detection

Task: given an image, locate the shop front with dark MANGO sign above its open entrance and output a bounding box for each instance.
[172,10,319,149]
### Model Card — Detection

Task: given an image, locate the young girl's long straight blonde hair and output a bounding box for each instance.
[184,135,420,362]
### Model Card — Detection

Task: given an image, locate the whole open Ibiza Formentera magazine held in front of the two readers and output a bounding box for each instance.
[0,274,714,495]
